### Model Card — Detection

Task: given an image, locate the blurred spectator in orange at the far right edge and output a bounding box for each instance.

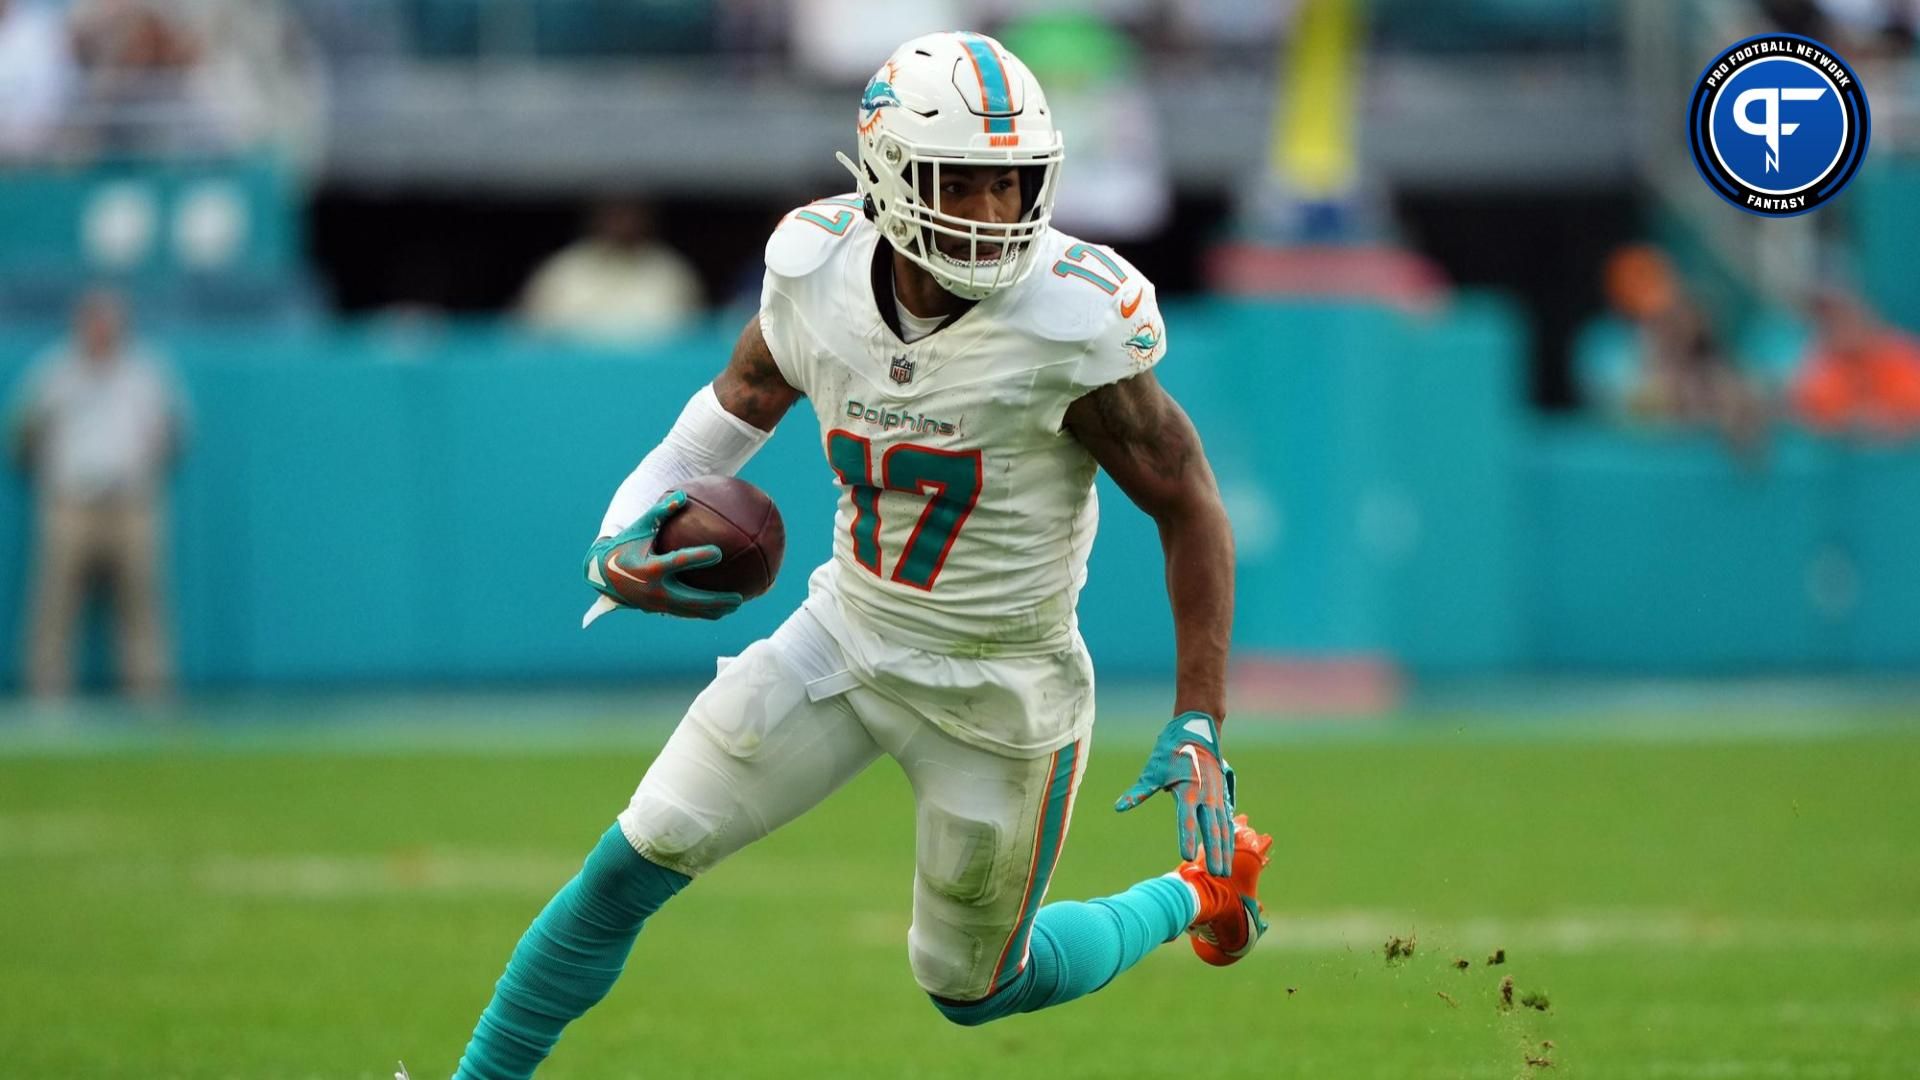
[1791,290,1920,436]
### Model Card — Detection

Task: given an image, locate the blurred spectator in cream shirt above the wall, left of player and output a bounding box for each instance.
[520,202,703,344]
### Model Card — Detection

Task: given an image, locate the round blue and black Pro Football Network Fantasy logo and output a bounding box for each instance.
[1688,35,1872,217]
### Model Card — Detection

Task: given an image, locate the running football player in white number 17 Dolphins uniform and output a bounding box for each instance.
[459,33,1271,1080]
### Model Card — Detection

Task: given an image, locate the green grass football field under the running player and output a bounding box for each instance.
[0,694,1920,1080]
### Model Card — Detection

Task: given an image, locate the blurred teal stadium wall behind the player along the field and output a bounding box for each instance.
[0,300,1920,686]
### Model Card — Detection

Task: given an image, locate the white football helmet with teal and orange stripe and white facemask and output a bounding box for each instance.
[839,31,1064,300]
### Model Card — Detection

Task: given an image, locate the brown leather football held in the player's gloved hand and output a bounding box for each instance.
[653,477,787,600]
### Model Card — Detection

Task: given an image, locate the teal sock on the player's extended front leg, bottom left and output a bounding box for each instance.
[453,824,691,1080]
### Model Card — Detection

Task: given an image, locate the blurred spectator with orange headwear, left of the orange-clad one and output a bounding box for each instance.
[1601,244,1764,446]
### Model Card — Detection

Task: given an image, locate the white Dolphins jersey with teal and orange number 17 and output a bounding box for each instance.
[760,196,1167,659]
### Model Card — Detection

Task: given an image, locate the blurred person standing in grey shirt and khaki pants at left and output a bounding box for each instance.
[10,292,184,698]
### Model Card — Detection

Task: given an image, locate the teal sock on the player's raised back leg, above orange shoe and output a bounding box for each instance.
[933,876,1194,1026]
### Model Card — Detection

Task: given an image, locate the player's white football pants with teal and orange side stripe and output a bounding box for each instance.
[620,607,1091,1001]
